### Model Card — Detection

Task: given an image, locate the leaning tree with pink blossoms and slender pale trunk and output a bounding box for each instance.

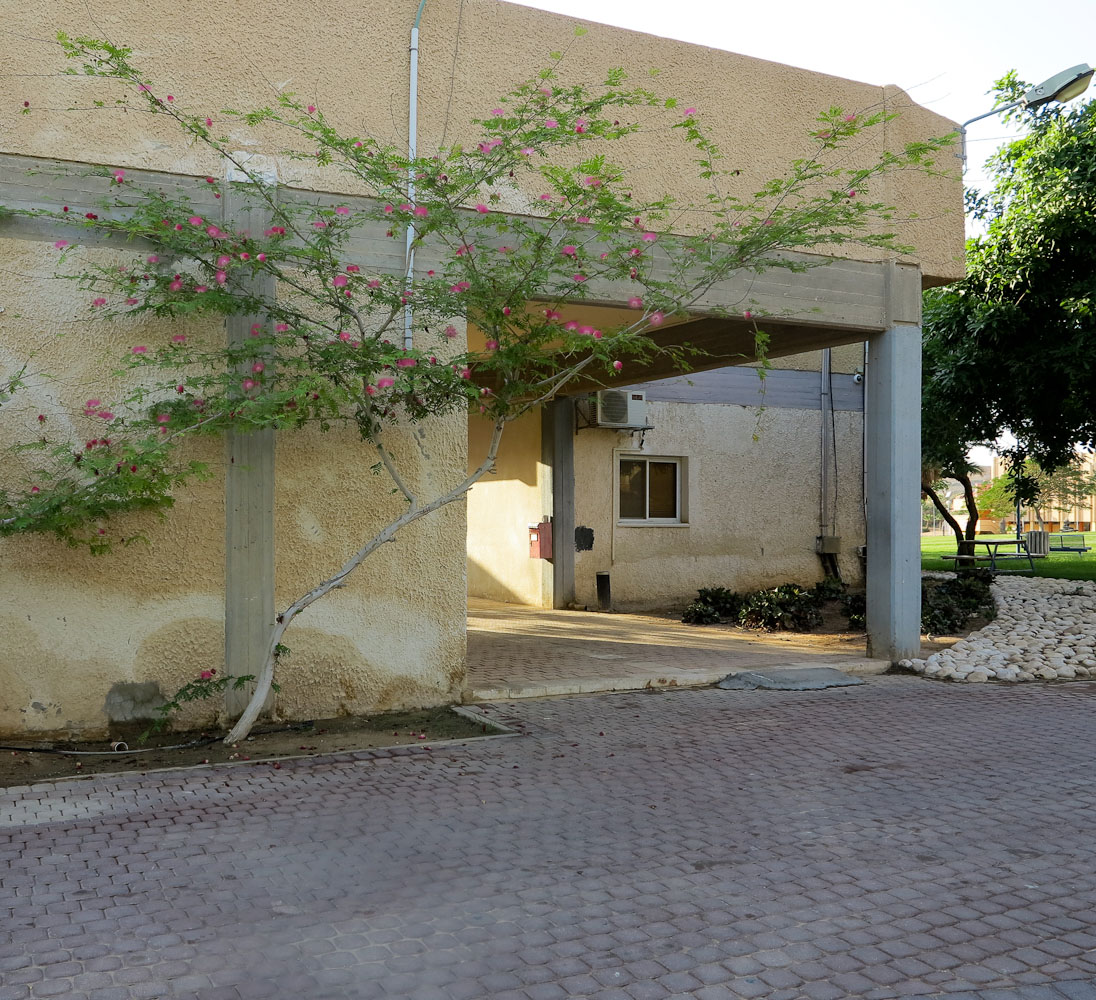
[0,36,947,741]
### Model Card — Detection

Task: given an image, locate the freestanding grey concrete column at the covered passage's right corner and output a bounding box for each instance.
[865,264,921,662]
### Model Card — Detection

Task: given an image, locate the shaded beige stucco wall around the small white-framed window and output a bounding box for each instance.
[574,402,864,610]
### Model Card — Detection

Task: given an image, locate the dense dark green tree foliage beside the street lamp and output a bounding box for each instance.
[922,80,1096,504]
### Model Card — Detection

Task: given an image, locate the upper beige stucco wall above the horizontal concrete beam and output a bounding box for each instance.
[0,0,963,282]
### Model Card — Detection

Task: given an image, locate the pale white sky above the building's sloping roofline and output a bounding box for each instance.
[511,0,1096,199]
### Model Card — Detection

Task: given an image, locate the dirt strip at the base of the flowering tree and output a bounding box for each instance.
[0,707,505,788]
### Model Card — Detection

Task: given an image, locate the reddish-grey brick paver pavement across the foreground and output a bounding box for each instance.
[0,677,1096,1000]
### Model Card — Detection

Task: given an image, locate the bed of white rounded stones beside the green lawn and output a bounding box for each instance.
[900,577,1096,684]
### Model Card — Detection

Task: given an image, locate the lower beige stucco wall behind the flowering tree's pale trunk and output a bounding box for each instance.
[0,239,466,735]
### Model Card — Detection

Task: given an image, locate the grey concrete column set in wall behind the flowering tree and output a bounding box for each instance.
[222,157,274,716]
